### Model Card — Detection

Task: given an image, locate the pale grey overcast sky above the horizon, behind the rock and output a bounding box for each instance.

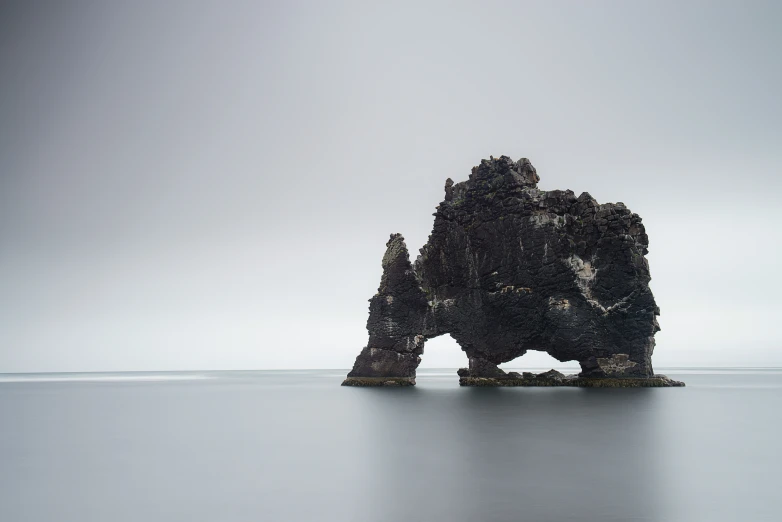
[0,0,782,372]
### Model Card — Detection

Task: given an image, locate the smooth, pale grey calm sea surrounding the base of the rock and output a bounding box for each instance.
[0,370,782,522]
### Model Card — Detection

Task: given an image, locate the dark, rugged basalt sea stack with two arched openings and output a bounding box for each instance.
[343,156,682,386]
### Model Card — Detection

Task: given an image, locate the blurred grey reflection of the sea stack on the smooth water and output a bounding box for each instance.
[357,382,662,521]
